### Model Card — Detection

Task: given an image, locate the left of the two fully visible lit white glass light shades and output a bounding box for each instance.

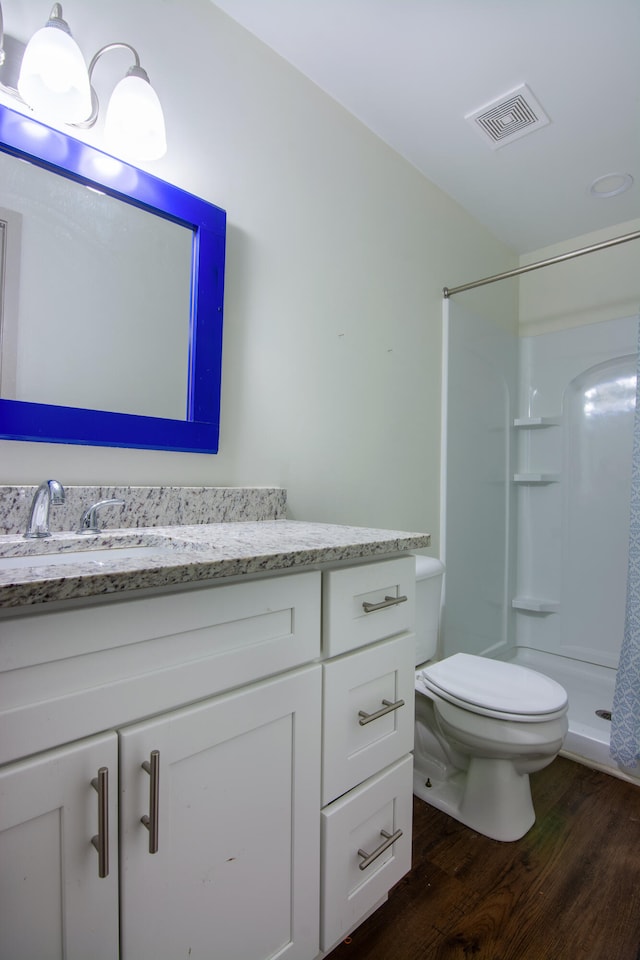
[18,26,91,123]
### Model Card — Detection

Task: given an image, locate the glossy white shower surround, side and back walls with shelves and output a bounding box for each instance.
[442,301,640,776]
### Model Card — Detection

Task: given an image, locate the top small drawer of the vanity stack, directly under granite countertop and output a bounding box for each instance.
[322,556,416,657]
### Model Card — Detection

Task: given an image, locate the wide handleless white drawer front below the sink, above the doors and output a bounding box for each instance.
[0,571,320,763]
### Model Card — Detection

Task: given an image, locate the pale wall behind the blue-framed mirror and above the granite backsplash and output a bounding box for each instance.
[0,0,516,540]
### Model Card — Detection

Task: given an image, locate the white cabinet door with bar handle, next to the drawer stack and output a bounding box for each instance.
[120,666,321,960]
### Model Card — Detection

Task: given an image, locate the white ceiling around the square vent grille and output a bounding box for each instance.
[215,0,640,253]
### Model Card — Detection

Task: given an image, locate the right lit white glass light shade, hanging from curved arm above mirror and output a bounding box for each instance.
[104,75,167,160]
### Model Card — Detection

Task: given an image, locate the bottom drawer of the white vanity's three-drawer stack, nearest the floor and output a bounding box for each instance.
[320,756,413,950]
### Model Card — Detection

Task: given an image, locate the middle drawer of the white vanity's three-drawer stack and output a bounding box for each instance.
[322,633,415,805]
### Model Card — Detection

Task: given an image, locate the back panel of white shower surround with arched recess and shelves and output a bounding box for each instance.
[512,316,638,772]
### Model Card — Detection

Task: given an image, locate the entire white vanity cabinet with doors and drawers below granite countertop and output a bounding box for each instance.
[0,556,415,960]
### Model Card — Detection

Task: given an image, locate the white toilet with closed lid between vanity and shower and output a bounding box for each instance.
[413,557,568,840]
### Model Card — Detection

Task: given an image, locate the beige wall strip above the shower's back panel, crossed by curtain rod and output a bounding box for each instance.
[519,218,640,336]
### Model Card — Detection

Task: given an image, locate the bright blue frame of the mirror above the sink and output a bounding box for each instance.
[0,104,226,453]
